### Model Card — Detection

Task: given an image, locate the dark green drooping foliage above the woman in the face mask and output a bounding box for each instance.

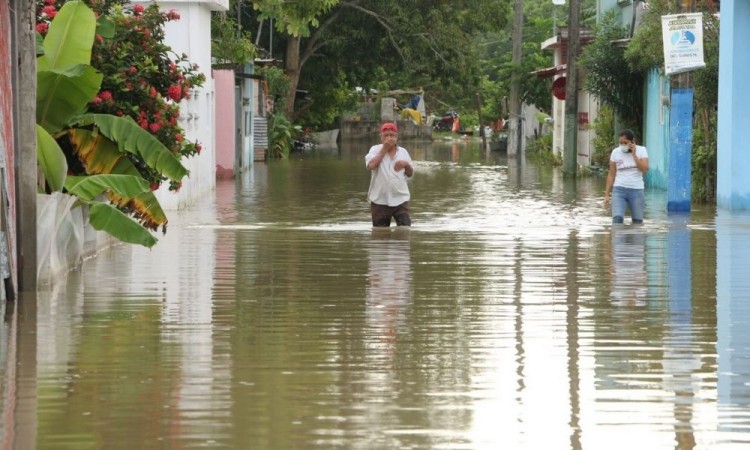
[580,11,645,124]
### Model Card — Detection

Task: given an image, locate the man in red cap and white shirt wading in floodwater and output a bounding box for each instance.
[365,122,414,227]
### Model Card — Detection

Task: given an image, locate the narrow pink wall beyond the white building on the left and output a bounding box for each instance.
[213,70,236,178]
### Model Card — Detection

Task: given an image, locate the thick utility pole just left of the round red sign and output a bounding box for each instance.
[563,0,581,178]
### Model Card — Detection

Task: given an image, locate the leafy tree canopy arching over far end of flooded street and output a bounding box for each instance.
[243,0,593,127]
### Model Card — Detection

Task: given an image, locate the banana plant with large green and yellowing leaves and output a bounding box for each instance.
[37,0,188,247]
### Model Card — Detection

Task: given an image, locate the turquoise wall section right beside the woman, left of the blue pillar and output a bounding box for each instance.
[636,69,670,189]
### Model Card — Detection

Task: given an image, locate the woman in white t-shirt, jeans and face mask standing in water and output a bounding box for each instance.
[604,130,648,224]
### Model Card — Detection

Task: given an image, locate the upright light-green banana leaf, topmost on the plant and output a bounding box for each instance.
[37,1,96,71]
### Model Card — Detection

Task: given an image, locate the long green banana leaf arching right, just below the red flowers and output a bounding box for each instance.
[73,114,188,181]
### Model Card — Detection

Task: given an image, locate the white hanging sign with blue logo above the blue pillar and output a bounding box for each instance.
[661,13,706,75]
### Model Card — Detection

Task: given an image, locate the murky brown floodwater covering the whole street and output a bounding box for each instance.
[0,142,750,450]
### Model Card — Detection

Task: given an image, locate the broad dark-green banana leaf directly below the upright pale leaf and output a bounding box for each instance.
[36,64,102,133]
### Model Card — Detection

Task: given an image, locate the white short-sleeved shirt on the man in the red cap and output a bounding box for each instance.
[365,144,412,206]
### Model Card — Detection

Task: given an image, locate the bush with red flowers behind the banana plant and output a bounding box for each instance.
[37,0,205,190]
